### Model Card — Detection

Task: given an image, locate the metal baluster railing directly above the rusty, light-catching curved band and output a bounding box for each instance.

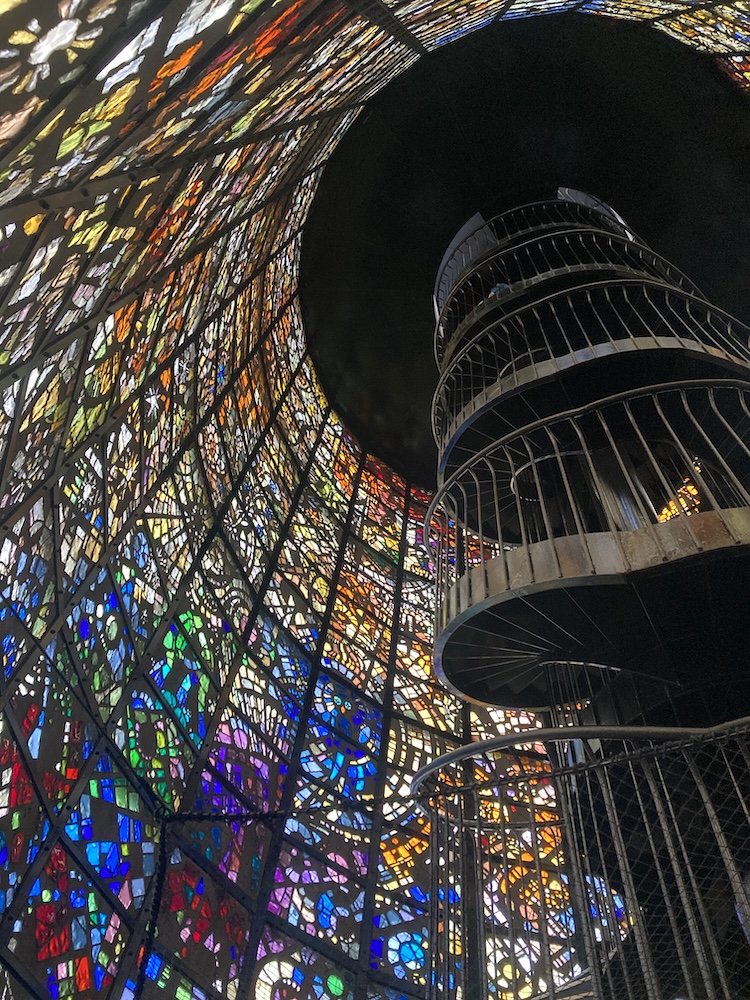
[425,380,750,631]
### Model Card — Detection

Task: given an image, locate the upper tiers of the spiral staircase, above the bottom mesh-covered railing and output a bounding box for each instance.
[428,191,750,708]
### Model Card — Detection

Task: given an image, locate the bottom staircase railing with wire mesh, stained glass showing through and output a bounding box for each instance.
[412,718,750,1000]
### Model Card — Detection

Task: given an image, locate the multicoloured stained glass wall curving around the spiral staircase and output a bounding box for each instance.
[0,0,750,1000]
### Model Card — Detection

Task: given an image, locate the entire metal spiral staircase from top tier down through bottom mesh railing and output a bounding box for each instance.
[413,189,750,1000]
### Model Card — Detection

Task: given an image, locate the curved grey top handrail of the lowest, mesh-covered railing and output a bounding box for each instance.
[410,716,750,797]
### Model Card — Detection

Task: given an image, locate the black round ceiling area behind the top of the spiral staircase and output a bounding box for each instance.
[301,14,750,487]
